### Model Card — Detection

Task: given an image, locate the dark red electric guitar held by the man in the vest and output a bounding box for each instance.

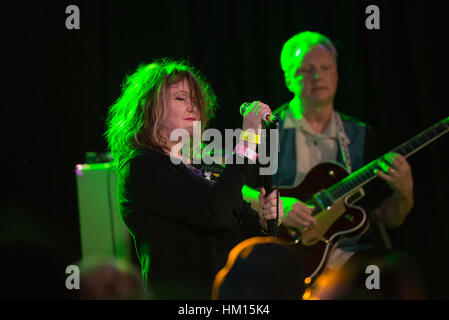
[278,117,449,284]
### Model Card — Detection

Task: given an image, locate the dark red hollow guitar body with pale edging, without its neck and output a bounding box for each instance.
[278,163,369,282]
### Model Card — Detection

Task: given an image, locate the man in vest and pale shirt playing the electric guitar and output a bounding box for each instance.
[242,31,423,298]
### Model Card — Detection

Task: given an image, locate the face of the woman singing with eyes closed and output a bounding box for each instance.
[159,79,200,140]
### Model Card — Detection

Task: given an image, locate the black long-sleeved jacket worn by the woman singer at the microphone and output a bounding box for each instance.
[118,149,261,299]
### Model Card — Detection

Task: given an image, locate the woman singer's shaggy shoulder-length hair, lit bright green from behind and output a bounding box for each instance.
[105,58,216,168]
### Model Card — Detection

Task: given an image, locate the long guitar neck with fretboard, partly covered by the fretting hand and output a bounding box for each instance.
[327,117,449,200]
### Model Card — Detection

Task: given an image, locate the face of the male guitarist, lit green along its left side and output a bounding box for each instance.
[287,45,338,103]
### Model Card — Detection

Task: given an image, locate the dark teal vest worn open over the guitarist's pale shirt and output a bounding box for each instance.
[279,104,366,187]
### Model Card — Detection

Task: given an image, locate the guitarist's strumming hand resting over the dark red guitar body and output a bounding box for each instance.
[282,197,317,231]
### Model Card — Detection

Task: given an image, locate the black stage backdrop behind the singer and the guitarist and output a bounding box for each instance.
[0,0,449,299]
